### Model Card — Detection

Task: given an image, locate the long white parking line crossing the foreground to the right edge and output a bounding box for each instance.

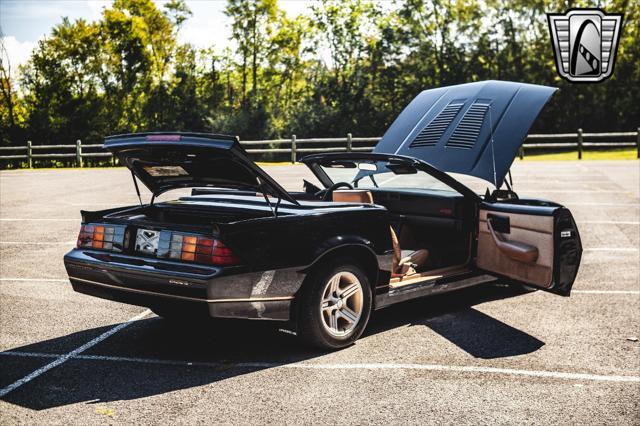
[0,351,640,384]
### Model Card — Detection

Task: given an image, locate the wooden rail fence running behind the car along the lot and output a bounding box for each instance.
[0,128,640,168]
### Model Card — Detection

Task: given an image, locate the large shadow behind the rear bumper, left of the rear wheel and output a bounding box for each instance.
[0,317,318,410]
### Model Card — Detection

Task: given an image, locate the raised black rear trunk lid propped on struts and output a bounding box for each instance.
[104,133,298,204]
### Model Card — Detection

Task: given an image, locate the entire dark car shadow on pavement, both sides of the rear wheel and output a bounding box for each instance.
[0,286,544,410]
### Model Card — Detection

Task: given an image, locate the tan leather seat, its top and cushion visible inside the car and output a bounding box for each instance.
[332,189,429,277]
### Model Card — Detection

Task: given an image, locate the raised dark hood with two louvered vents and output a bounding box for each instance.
[373,81,557,188]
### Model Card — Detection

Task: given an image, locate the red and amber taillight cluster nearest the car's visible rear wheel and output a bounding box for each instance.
[169,233,240,266]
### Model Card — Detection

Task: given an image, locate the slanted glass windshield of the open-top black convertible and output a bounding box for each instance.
[320,160,457,192]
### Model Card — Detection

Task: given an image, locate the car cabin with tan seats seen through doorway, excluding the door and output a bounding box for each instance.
[296,159,475,286]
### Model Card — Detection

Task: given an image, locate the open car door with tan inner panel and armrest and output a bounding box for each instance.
[476,202,582,296]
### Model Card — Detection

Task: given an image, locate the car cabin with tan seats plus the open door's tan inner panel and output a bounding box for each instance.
[298,175,570,288]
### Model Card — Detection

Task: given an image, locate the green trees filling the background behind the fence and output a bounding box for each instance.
[0,0,640,155]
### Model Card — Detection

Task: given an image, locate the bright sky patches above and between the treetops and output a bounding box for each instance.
[0,0,315,69]
